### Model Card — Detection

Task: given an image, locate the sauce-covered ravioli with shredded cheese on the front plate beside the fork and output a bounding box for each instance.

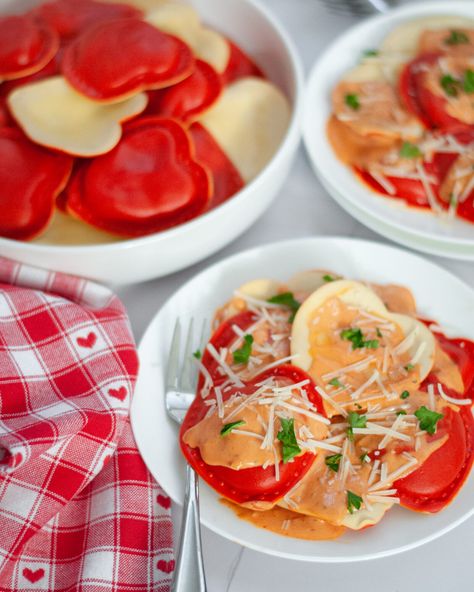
[180,270,474,540]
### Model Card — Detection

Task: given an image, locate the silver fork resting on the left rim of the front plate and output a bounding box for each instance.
[165,319,207,592]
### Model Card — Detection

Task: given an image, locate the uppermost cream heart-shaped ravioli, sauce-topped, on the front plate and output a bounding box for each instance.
[291,280,435,414]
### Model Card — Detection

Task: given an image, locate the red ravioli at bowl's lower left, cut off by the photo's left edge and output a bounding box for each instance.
[0,127,73,240]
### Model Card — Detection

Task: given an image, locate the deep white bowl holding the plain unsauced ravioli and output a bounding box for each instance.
[0,0,303,284]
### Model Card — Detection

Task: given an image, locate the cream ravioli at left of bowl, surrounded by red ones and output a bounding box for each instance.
[8,76,147,156]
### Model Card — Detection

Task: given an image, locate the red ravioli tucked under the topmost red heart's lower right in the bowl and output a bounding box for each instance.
[146,60,222,121]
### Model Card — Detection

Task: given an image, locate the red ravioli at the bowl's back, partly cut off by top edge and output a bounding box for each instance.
[33,0,143,39]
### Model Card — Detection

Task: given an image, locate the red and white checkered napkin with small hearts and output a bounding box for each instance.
[0,258,174,592]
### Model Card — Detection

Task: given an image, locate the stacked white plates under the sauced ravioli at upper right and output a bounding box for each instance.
[303,2,474,259]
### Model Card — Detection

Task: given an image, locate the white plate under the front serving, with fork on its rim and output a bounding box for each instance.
[132,238,474,562]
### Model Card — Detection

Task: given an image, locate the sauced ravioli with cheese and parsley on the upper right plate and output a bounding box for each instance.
[327,16,474,223]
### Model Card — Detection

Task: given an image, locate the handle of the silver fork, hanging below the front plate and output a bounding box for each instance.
[171,465,207,592]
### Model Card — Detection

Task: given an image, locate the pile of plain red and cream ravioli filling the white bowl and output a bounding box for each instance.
[0,0,290,243]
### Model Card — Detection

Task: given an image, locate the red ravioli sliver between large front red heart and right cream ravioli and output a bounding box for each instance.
[189,121,245,208]
